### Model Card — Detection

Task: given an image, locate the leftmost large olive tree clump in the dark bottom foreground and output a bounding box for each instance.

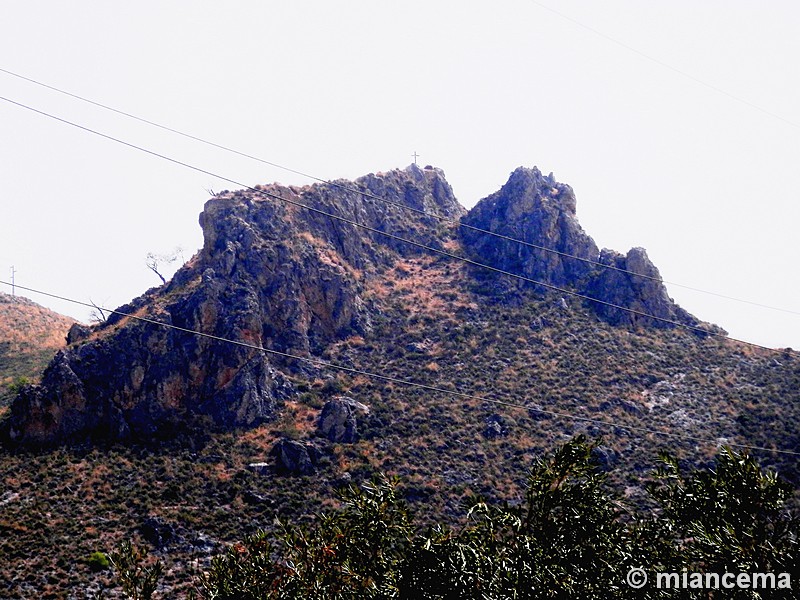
[201,476,413,600]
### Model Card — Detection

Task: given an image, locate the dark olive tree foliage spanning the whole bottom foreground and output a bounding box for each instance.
[109,437,798,600]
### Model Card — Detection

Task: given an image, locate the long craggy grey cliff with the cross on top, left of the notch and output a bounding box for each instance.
[0,165,465,445]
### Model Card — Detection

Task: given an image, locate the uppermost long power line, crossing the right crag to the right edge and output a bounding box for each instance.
[0,65,800,315]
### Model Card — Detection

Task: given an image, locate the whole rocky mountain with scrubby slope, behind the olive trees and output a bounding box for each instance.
[0,165,800,598]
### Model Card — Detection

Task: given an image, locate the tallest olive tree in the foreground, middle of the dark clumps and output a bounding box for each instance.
[402,437,630,599]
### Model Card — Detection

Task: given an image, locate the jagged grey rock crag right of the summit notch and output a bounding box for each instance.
[461,167,697,327]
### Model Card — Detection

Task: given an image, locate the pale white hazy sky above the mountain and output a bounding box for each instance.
[0,0,800,348]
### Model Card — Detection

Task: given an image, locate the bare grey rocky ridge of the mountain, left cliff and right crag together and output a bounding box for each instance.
[0,165,693,445]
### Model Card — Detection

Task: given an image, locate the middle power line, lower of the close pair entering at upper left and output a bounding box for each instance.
[0,96,775,351]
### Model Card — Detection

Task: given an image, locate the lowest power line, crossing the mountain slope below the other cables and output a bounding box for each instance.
[0,280,800,456]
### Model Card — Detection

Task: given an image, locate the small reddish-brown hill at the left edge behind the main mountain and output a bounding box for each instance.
[0,292,75,406]
